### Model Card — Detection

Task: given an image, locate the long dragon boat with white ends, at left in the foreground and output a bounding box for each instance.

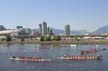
[9,56,51,62]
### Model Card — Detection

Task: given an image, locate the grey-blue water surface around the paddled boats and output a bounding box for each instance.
[0,44,108,71]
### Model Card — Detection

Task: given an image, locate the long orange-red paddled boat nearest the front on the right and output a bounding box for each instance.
[57,55,102,60]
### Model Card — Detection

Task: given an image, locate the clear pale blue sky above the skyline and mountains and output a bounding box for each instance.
[0,0,108,32]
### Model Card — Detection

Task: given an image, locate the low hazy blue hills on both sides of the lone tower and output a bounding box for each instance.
[53,29,90,35]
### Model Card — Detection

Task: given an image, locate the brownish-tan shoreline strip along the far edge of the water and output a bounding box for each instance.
[0,40,108,44]
